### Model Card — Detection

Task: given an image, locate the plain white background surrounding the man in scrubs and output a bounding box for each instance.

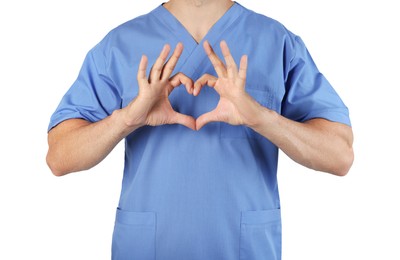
[0,0,400,260]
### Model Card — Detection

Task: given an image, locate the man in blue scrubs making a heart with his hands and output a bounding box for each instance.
[47,0,353,260]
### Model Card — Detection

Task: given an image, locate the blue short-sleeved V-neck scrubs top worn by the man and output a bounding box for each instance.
[49,3,350,260]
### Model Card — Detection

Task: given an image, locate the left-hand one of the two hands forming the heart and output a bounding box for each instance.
[125,43,196,130]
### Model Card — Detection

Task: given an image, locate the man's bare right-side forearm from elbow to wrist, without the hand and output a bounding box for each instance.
[253,108,353,176]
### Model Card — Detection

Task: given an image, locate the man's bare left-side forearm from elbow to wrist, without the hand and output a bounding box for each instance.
[46,107,138,176]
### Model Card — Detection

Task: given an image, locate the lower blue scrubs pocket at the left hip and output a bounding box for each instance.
[112,209,156,260]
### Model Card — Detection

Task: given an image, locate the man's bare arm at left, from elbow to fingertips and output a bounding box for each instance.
[46,43,196,176]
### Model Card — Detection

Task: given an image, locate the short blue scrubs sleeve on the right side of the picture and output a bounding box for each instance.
[281,36,351,125]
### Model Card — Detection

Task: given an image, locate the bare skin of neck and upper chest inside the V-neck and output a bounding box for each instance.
[164,0,233,42]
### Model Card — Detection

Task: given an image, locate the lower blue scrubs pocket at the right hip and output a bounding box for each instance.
[240,209,282,260]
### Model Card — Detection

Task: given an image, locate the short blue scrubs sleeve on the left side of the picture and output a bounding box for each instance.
[48,45,121,131]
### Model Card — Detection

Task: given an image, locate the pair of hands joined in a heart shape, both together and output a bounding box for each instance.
[128,41,258,130]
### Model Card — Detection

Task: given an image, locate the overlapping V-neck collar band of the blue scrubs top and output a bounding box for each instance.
[152,2,244,77]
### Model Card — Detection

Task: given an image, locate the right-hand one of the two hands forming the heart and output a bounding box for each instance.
[193,41,262,130]
